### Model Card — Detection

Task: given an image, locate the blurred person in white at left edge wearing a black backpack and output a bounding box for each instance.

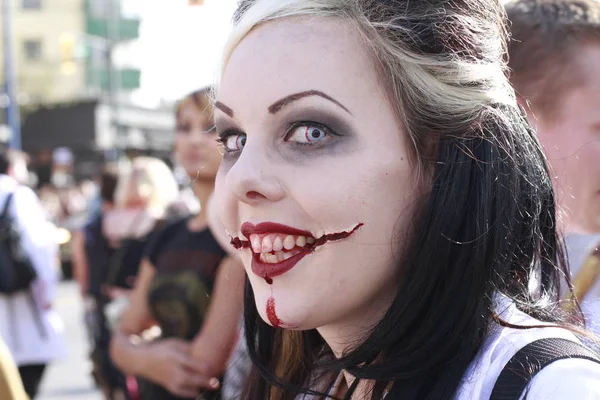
[0,151,66,398]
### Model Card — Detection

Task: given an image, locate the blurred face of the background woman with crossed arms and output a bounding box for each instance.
[175,102,221,181]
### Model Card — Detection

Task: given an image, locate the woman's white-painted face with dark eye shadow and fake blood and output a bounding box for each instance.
[215,18,419,352]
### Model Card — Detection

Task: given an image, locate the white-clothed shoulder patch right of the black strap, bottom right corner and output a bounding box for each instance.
[528,359,600,400]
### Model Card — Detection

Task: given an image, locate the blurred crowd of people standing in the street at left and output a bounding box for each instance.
[0,89,243,399]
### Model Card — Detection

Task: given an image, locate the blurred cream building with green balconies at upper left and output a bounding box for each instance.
[0,0,140,106]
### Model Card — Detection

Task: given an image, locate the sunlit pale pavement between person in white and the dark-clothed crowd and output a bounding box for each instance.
[36,282,102,400]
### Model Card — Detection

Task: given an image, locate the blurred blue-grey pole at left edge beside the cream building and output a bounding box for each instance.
[0,0,21,150]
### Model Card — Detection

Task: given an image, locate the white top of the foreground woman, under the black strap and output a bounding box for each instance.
[297,296,600,400]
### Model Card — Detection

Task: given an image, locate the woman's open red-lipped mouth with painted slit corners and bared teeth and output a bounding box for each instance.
[231,222,363,284]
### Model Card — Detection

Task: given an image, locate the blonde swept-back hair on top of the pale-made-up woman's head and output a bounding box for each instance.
[215,0,516,173]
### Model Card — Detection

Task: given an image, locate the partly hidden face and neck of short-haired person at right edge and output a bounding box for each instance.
[533,43,600,233]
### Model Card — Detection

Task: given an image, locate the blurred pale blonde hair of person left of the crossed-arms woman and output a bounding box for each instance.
[115,157,179,217]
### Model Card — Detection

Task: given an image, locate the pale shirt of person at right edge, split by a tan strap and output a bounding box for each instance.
[565,234,600,335]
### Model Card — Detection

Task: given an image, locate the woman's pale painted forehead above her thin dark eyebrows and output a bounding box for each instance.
[218,18,379,117]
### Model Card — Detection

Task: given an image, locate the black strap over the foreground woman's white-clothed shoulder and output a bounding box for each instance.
[490,338,600,400]
